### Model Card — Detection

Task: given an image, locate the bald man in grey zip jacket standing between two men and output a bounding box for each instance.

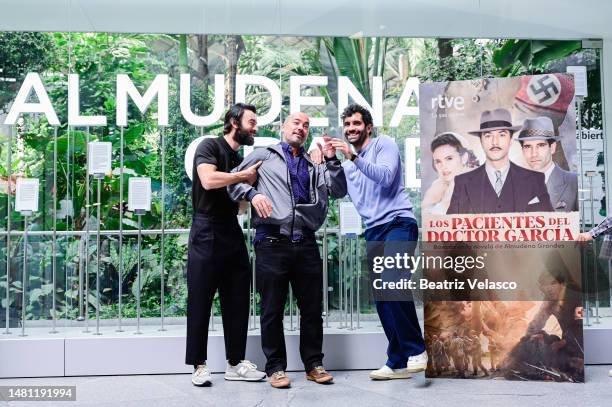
[228,112,346,388]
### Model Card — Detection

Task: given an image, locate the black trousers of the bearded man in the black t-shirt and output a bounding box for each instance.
[185,214,251,365]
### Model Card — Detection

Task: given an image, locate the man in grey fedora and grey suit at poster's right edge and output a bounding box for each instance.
[517,116,578,212]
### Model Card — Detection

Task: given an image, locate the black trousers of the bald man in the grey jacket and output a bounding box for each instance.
[255,238,323,375]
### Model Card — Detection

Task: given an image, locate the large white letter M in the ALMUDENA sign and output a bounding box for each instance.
[117,74,168,126]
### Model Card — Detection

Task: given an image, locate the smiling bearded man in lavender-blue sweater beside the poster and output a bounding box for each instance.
[325,104,427,380]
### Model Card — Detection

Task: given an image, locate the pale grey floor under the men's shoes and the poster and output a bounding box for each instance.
[0,366,612,407]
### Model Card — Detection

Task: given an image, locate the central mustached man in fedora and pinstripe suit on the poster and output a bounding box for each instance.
[446,108,553,214]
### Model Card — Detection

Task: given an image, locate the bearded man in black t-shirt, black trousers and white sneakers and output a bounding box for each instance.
[185,103,266,386]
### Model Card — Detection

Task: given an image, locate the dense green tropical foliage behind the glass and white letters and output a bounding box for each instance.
[0,33,601,326]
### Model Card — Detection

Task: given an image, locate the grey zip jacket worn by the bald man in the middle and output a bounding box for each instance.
[227,143,346,236]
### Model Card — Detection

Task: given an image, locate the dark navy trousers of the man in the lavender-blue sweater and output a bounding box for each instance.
[365,217,425,369]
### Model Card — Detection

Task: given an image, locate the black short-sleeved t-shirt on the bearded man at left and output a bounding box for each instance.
[191,136,242,216]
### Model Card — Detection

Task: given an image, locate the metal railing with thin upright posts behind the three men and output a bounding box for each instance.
[0,226,372,335]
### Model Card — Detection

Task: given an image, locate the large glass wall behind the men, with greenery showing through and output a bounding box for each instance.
[0,32,609,334]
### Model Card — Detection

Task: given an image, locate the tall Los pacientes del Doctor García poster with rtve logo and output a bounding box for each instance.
[419,74,584,382]
